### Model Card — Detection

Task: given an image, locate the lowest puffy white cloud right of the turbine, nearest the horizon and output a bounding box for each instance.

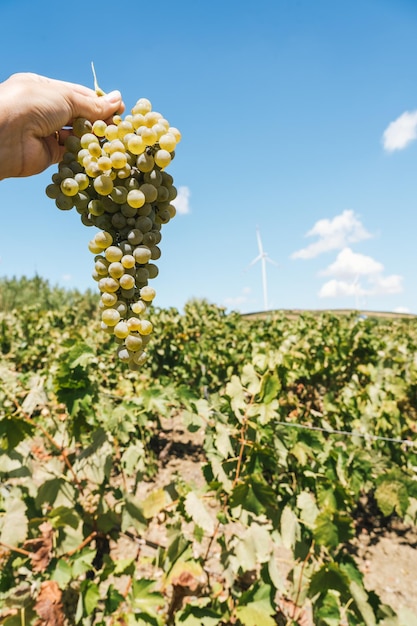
[319,248,403,298]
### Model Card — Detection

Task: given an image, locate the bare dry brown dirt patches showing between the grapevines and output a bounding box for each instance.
[128,412,417,626]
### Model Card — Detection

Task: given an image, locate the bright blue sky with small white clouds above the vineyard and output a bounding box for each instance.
[0,0,417,313]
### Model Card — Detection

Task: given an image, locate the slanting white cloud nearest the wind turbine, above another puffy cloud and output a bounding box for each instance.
[291,210,372,259]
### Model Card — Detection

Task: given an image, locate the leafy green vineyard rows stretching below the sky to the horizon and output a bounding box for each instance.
[0,277,417,626]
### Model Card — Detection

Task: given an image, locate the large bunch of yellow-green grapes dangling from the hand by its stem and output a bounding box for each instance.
[46,98,181,370]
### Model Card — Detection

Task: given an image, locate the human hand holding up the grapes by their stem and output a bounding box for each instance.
[0,73,125,179]
